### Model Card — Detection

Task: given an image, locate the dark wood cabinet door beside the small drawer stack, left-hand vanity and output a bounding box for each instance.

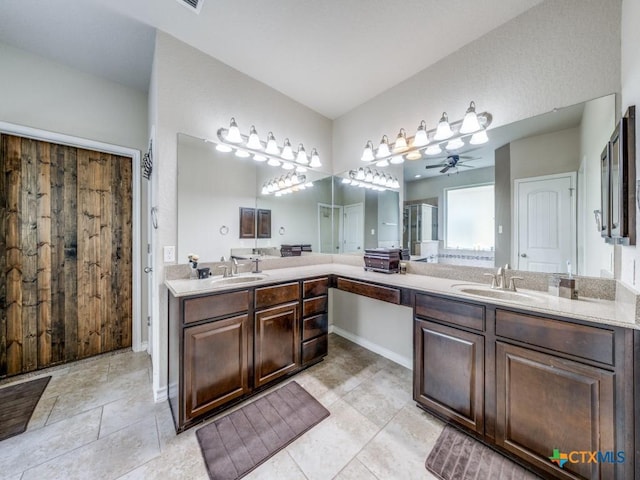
[255,302,300,387]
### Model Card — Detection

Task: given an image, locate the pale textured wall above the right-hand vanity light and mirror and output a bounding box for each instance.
[333,0,620,172]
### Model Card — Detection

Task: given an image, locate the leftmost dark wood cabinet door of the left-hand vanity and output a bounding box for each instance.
[184,315,251,420]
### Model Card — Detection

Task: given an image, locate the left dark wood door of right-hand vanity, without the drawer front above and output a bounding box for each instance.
[413,319,484,433]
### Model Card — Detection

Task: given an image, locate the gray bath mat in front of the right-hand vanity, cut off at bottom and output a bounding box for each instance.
[425,426,541,480]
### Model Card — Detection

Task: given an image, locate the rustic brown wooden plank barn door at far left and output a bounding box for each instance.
[0,135,132,376]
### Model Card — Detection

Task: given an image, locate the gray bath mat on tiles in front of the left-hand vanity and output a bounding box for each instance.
[196,382,329,480]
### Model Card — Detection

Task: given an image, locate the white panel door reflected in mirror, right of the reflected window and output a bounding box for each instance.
[513,172,576,273]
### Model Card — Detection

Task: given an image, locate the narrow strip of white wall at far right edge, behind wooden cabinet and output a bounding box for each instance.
[619,0,640,289]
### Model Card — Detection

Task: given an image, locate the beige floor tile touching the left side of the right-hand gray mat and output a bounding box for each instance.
[357,404,444,480]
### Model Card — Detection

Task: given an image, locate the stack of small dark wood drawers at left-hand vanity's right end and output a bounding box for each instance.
[302,277,329,366]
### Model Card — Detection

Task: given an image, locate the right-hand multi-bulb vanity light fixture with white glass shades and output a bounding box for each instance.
[360,101,493,167]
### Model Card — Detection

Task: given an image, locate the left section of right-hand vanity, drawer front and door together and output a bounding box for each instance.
[413,294,485,434]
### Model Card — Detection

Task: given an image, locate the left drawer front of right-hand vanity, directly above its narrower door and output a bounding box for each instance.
[416,293,484,331]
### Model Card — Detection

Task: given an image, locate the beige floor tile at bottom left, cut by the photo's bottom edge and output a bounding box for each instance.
[22,419,160,480]
